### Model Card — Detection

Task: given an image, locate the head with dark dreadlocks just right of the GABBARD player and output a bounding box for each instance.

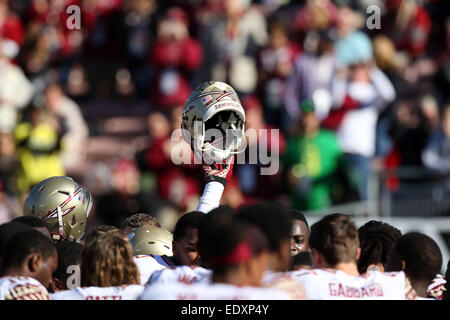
[358,220,402,273]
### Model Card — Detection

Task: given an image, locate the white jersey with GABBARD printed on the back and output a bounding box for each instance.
[288,269,417,300]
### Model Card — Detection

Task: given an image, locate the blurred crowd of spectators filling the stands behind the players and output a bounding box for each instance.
[0,0,450,230]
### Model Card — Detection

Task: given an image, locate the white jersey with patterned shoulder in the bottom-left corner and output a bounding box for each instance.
[0,277,50,300]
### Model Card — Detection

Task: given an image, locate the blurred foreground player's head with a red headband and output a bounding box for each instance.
[199,211,269,286]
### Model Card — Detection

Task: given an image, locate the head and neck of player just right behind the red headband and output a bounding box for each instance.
[237,203,292,271]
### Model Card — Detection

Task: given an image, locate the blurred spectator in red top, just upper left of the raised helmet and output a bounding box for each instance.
[150,7,203,108]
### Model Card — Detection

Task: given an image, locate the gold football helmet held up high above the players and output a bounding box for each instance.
[181,81,246,162]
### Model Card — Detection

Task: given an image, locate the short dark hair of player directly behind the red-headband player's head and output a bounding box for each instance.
[237,202,292,252]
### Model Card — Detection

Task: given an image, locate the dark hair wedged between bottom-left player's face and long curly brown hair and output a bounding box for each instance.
[53,240,83,284]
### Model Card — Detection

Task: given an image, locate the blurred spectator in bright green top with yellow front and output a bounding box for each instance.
[283,100,342,210]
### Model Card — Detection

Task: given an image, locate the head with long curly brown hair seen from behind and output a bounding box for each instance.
[80,234,140,287]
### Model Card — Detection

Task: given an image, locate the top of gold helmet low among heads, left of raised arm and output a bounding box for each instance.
[128,226,173,257]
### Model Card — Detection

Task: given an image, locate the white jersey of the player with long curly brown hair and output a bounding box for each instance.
[50,284,144,300]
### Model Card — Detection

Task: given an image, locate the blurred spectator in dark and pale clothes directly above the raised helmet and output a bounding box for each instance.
[199,0,269,94]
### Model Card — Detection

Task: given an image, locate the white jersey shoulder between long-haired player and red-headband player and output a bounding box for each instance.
[148,266,212,284]
